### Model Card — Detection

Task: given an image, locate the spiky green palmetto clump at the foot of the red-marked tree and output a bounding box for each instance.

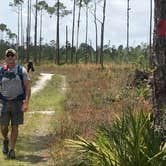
[66,109,166,166]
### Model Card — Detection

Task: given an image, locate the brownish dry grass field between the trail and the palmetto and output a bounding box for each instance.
[35,64,151,165]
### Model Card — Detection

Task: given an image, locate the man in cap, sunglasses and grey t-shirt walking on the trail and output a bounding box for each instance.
[0,49,31,159]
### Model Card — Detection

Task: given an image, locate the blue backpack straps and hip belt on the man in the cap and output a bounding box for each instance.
[0,64,26,101]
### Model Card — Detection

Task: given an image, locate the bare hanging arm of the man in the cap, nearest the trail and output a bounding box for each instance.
[22,80,31,112]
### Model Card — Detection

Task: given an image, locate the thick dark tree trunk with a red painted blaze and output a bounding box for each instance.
[153,0,166,136]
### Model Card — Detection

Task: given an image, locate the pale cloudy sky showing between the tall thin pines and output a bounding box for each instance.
[0,0,153,47]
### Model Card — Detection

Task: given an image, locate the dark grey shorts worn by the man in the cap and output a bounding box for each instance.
[0,100,24,125]
